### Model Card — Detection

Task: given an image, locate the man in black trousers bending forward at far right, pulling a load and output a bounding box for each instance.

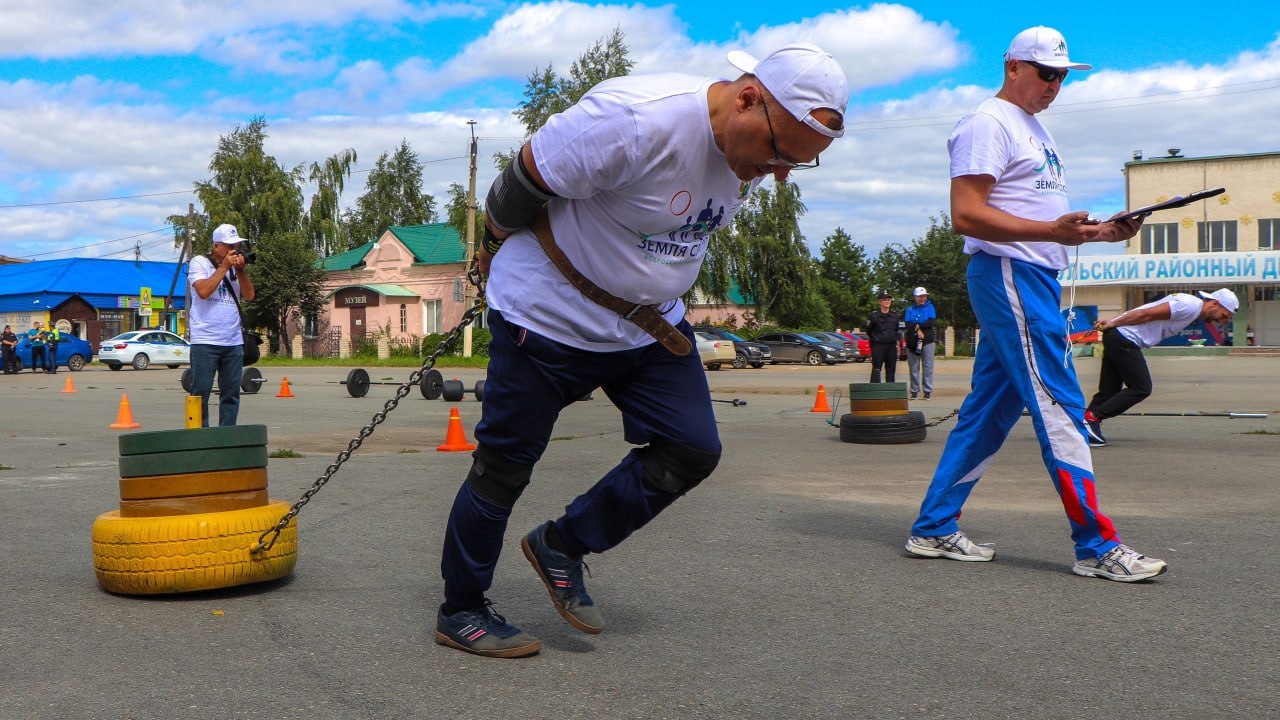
[1084,287,1240,447]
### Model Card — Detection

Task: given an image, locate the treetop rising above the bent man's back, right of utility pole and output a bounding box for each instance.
[493,27,635,169]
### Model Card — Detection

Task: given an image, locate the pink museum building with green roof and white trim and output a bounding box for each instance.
[309,223,483,354]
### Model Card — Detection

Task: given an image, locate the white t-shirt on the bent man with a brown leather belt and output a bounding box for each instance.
[486,74,759,351]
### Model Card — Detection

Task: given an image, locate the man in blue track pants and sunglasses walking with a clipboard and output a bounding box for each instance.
[906,27,1166,582]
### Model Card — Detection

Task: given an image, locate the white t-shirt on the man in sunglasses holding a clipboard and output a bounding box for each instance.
[947,97,1070,270]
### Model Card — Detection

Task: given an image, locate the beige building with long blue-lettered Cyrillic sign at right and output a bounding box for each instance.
[1059,150,1280,347]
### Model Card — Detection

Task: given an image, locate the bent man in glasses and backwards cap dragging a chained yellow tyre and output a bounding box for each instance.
[435,44,849,657]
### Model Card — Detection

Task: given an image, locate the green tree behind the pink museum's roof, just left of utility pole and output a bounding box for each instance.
[344,140,436,250]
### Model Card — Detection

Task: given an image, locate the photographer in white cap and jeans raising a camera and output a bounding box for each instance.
[187,223,257,428]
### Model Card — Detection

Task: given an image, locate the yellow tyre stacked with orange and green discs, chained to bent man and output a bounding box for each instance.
[92,425,298,594]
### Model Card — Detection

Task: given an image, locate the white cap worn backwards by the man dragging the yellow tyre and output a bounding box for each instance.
[728,42,849,137]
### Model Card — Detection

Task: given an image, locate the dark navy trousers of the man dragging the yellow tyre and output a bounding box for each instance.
[440,309,721,607]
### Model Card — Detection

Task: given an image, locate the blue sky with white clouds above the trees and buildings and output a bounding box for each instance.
[0,0,1280,260]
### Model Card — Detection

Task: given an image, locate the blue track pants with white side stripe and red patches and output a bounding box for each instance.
[911,252,1119,560]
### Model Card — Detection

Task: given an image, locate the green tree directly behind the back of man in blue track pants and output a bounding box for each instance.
[876,213,978,328]
